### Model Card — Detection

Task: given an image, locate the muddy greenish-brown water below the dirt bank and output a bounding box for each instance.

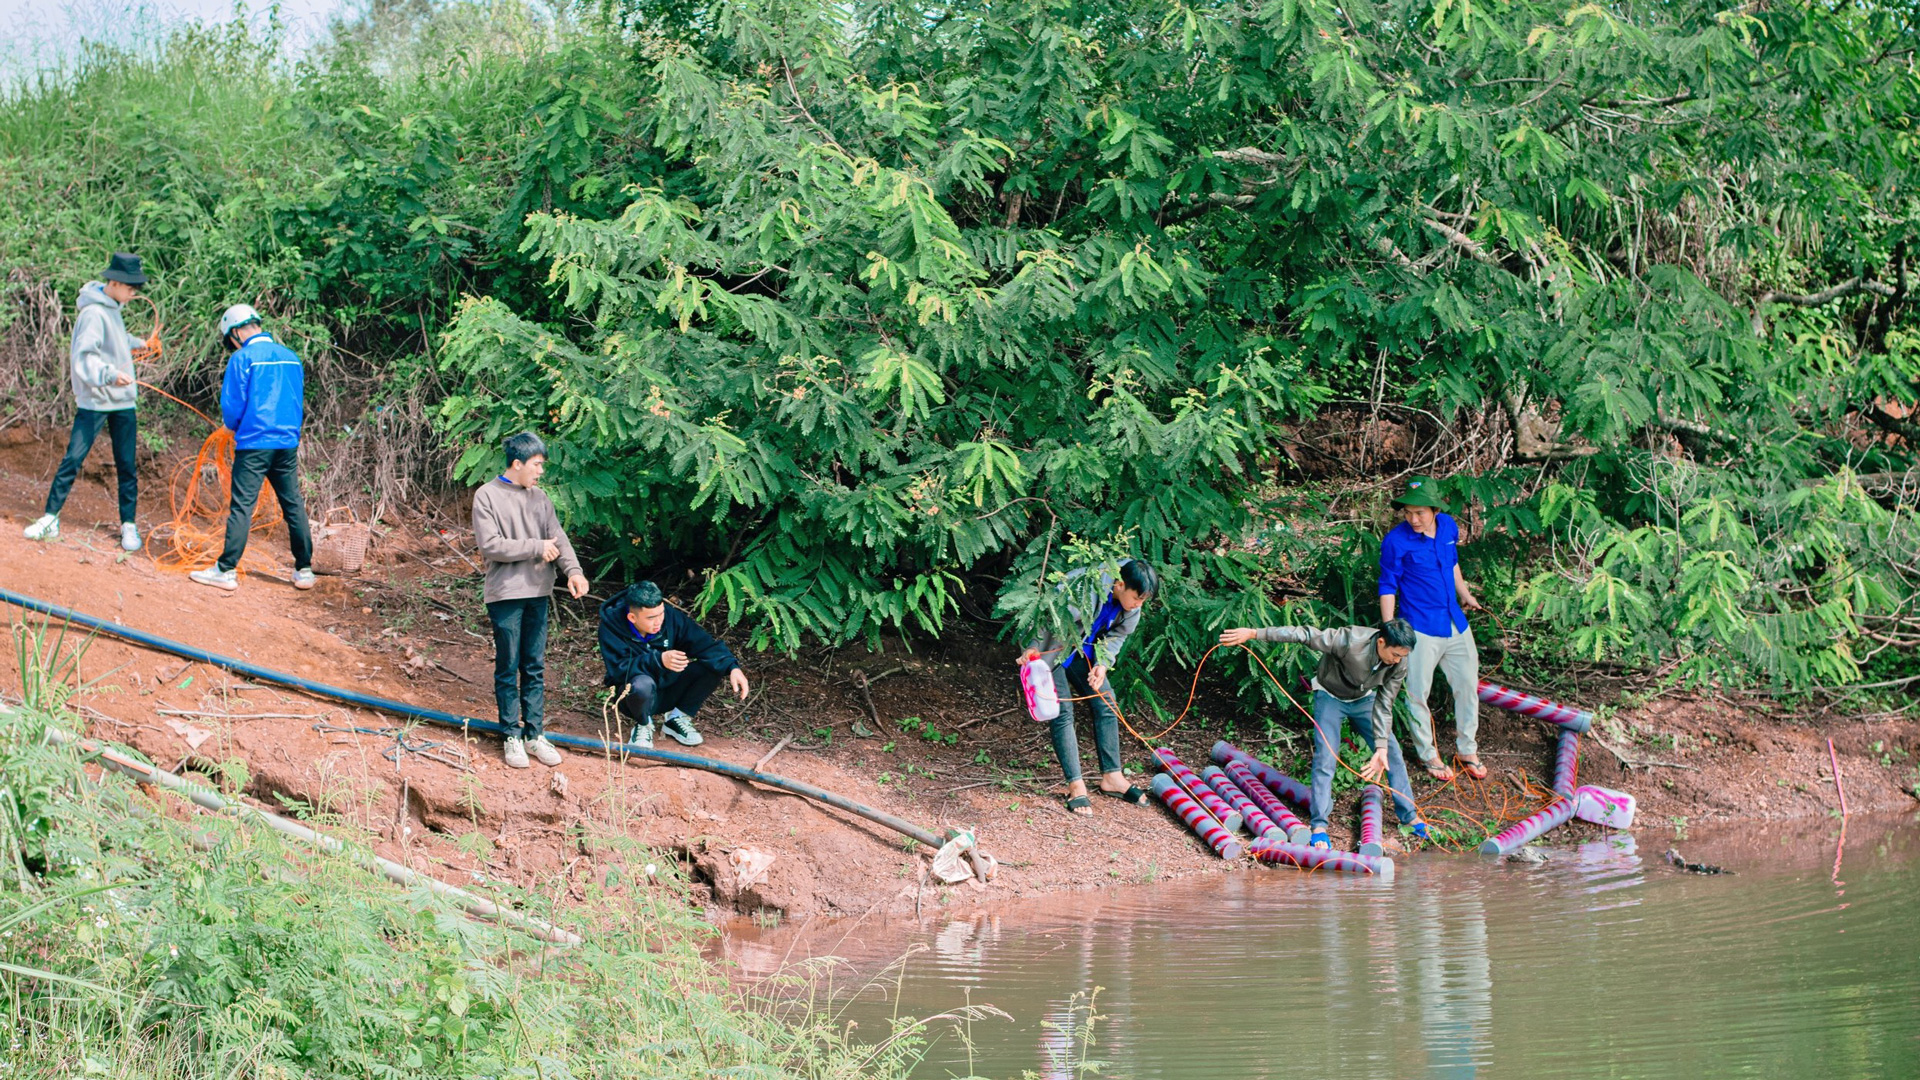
[716,817,1920,1080]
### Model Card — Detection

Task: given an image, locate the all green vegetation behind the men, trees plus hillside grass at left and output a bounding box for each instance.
[0,0,1920,686]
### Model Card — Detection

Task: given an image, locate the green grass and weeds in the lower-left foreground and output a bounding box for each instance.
[0,626,990,1080]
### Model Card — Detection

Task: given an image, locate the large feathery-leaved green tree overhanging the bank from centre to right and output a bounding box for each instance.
[444,0,1920,684]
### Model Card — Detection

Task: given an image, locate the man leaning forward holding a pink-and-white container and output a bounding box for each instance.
[1020,559,1160,815]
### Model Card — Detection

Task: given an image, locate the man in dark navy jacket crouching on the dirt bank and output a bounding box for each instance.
[599,580,749,746]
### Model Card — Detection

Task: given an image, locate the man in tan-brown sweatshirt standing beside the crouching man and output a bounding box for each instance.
[474,430,588,769]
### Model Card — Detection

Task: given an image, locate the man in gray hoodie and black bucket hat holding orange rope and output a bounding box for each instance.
[27,252,146,552]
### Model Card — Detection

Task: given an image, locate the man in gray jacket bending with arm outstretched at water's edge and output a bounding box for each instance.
[1219,619,1427,847]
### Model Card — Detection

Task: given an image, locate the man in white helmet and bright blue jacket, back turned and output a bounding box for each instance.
[186,304,313,592]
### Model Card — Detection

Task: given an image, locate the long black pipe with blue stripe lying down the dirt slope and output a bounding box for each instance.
[0,588,943,851]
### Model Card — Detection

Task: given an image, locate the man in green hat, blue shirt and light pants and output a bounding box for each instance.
[1380,477,1486,780]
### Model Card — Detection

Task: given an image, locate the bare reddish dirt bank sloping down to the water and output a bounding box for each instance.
[0,429,1920,915]
